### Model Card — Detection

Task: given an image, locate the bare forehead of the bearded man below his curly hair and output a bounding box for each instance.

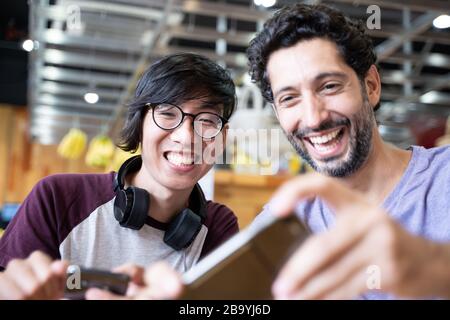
[267,38,356,92]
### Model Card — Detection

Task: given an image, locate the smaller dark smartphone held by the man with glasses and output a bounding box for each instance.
[64,265,130,300]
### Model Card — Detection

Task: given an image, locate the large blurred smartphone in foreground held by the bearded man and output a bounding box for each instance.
[181,214,311,300]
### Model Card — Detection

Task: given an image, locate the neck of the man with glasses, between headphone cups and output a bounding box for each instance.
[130,163,192,223]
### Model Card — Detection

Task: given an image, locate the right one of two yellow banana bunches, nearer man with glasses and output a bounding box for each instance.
[85,134,116,168]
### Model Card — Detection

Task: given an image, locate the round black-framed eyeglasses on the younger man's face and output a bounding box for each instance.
[146,103,228,139]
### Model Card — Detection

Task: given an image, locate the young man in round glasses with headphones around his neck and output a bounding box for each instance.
[0,53,238,297]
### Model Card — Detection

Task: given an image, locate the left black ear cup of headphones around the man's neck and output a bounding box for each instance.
[121,187,150,230]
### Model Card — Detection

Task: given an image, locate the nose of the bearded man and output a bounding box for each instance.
[301,94,329,128]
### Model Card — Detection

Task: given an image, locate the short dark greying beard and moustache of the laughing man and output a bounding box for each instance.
[285,97,375,178]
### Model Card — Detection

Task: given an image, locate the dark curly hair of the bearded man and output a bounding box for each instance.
[247,4,379,110]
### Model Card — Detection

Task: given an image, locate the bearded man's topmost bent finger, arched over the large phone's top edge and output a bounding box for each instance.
[269,173,365,216]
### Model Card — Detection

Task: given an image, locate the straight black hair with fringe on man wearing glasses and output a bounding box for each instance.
[118,53,236,152]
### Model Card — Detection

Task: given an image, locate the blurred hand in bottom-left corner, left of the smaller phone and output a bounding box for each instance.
[0,251,68,300]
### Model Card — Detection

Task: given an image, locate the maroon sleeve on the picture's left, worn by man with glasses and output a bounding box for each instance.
[0,174,114,268]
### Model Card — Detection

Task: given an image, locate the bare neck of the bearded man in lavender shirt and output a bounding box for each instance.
[343,127,412,205]
